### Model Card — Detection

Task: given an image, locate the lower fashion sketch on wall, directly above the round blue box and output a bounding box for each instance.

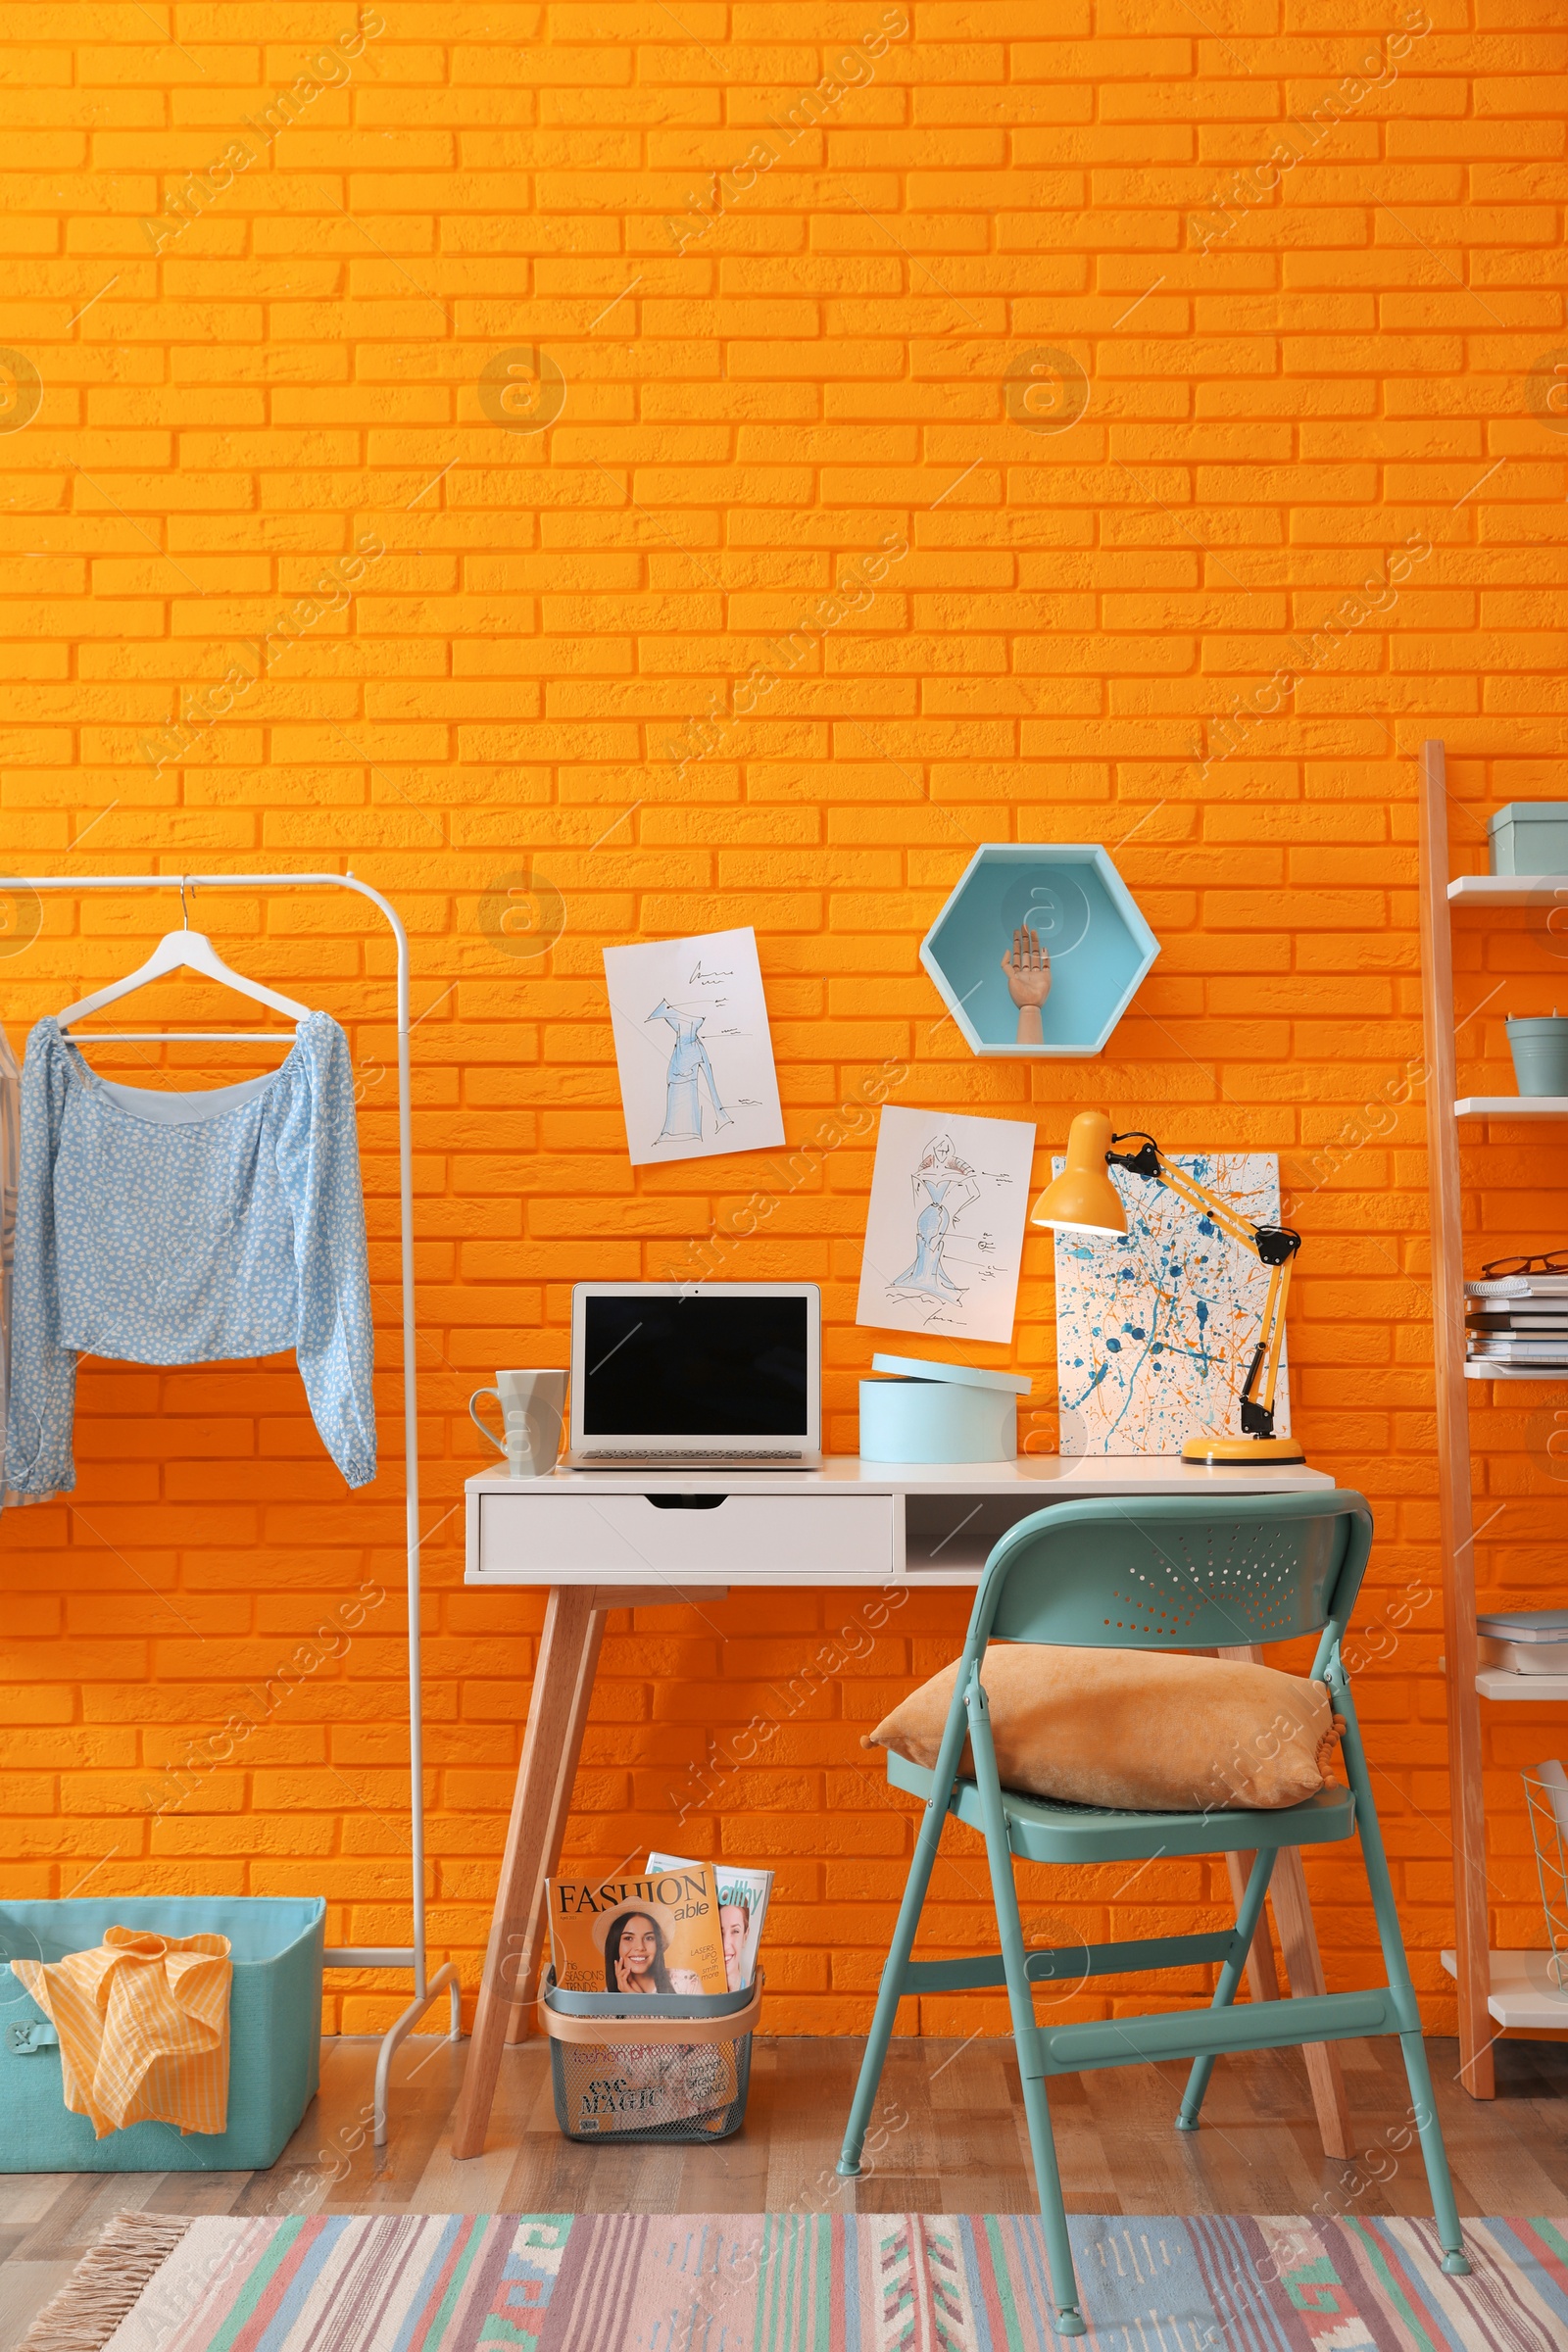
[856,1103,1034,1343]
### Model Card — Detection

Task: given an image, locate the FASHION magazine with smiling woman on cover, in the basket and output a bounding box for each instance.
[548,1863,736,2133]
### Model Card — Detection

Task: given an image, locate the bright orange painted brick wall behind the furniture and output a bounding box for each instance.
[0,0,1568,2033]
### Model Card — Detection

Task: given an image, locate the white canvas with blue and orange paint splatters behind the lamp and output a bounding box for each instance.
[1054,1152,1291,1453]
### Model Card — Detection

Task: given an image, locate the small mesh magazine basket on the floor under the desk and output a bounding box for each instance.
[538,1969,761,2142]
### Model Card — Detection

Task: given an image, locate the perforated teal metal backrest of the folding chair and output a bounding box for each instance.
[971,1489,1373,1648]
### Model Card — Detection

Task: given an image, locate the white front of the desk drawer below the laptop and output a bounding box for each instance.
[477,1489,894,1586]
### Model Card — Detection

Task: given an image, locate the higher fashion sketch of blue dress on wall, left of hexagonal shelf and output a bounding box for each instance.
[604,929,783,1166]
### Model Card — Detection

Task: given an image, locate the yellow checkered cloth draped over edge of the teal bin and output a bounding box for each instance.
[12,1927,235,2138]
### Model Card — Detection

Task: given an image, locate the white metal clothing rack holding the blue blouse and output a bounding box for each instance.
[0,872,461,2147]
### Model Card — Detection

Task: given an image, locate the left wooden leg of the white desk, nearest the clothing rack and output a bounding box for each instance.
[452,1586,604,2157]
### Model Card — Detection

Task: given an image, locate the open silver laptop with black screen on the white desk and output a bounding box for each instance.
[569,1282,823,1470]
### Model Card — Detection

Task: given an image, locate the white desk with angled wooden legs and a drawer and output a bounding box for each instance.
[452,1453,1351,2157]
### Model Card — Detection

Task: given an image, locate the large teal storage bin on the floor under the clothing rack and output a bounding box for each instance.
[0,1895,326,2174]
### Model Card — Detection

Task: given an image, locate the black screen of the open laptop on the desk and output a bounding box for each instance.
[581,1292,808,1440]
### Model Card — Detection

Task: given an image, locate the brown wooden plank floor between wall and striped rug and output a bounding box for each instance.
[0,2039,1568,2352]
